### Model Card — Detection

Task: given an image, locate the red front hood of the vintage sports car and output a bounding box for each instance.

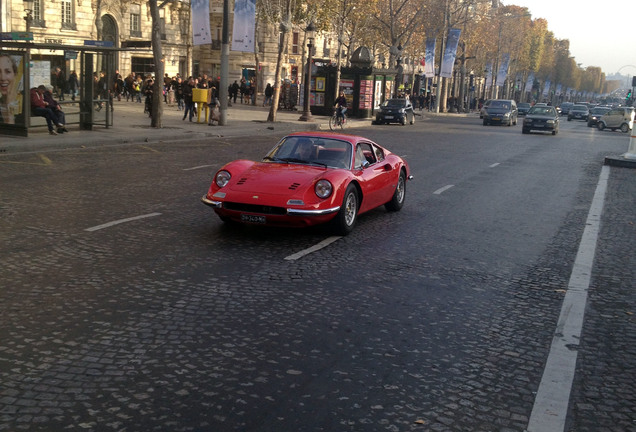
[227,162,326,195]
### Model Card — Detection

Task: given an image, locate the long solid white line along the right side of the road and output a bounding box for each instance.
[527,166,609,432]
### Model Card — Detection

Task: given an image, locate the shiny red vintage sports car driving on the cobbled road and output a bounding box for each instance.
[201,132,412,235]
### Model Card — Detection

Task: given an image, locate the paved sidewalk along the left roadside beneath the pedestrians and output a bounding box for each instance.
[0,100,371,153]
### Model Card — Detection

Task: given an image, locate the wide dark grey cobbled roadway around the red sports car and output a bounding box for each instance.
[0,117,636,432]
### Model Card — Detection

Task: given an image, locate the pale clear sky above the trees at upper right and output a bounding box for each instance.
[501,0,636,76]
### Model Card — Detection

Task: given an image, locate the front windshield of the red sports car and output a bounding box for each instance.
[264,136,352,168]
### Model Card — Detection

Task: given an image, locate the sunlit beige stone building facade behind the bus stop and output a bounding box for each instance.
[0,0,342,91]
